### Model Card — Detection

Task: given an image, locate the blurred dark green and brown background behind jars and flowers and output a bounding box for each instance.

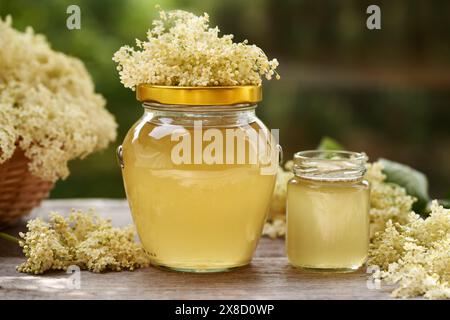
[0,0,450,198]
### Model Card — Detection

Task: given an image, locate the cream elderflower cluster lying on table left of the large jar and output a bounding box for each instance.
[17,211,149,274]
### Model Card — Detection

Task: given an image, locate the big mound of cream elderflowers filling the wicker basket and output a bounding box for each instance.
[0,17,117,181]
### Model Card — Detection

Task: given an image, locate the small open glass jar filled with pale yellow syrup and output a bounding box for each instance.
[286,151,369,271]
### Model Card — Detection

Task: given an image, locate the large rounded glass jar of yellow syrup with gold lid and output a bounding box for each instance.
[120,85,278,272]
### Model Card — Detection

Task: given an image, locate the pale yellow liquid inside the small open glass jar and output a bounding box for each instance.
[286,178,369,271]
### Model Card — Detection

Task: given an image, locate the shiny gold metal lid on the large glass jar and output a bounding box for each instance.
[136,84,262,106]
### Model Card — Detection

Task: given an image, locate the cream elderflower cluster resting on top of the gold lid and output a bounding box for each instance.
[113,10,279,90]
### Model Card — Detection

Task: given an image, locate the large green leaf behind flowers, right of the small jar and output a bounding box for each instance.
[379,159,430,213]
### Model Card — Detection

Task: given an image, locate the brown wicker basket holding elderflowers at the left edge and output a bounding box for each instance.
[0,148,54,228]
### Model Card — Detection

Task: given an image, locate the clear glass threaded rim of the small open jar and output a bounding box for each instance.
[293,150,368,181]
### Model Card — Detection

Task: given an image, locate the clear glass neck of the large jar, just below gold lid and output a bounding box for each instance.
[142,102,257,127]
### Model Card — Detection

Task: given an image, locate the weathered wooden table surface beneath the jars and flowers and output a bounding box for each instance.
[0,199,392,299]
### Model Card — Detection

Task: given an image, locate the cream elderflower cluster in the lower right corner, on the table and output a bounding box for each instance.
[369,200,450,299]
